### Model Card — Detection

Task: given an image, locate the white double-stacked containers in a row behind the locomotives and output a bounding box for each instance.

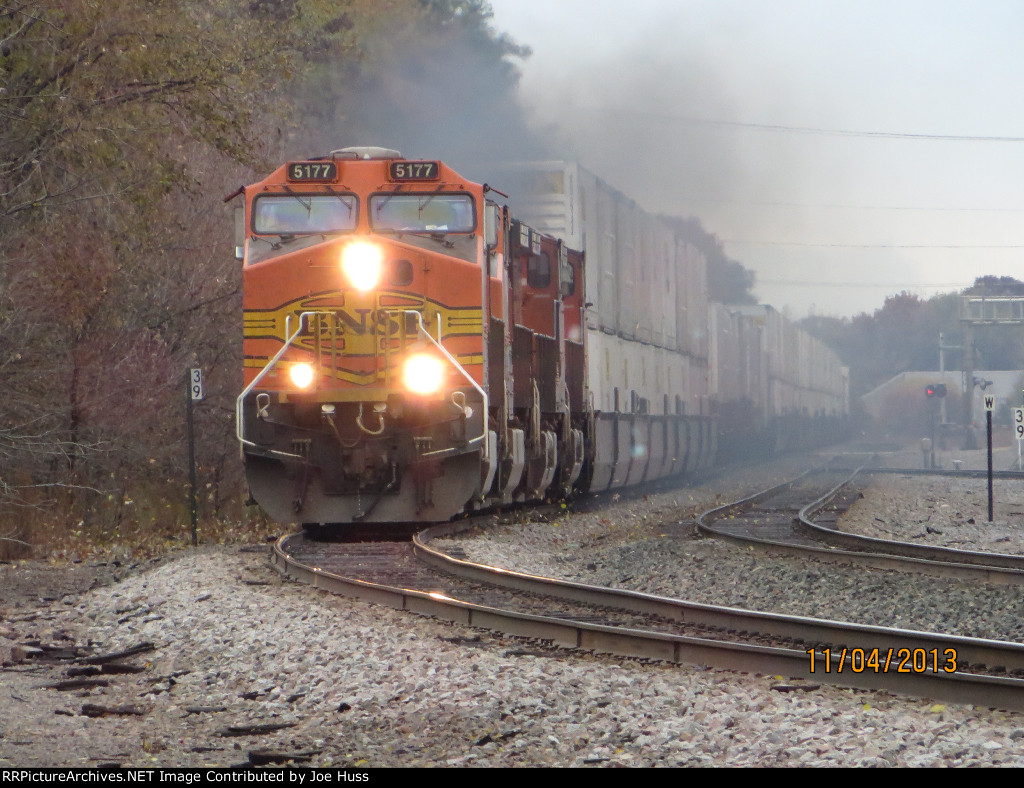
[507,162,850,459]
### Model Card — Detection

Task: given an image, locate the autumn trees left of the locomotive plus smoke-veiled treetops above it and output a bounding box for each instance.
[0,0,548,552]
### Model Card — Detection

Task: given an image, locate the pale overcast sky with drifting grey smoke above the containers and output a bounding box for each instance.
[492,0,1024,317]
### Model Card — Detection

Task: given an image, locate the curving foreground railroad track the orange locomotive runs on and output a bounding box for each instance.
[273,462,1024,710]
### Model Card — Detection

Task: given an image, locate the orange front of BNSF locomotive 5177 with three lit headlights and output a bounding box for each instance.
[238,148,491,523]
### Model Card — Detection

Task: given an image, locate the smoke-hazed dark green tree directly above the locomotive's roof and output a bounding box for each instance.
[289,0,551,170]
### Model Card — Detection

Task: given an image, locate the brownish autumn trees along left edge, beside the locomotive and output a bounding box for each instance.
[0,0,370,548]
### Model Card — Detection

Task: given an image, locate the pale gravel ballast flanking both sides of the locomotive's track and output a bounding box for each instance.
[0,450,1024,767]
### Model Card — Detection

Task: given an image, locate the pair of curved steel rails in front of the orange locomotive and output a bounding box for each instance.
[272,529,1024,711]
